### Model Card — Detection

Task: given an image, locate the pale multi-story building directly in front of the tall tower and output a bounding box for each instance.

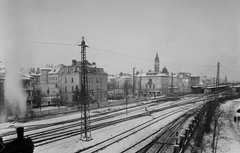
[136,71,169,96]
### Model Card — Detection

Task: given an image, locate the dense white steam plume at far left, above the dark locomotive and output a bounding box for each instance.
[4,42,30,117]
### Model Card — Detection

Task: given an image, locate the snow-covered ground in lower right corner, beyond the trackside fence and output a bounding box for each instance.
[204,99,240,153]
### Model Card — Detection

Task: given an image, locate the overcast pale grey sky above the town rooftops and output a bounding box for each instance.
[0,0,240,80]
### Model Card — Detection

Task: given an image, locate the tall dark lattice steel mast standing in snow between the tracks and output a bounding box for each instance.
[78,37,92,141]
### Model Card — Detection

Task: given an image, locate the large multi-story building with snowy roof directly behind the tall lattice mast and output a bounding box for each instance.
[58,60,107,104]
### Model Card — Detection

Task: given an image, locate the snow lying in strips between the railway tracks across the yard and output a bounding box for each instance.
[0,98,201,153]
